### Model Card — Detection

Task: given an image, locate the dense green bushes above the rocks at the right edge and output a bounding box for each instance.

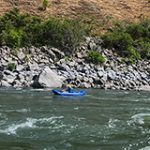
[102,20,150,61]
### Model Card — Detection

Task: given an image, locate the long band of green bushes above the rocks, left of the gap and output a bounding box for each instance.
[0,8,87,52]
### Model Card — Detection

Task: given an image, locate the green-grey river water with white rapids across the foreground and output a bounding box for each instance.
[0,89,150,150]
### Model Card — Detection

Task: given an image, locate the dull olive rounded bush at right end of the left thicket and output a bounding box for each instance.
[38,18,86,52]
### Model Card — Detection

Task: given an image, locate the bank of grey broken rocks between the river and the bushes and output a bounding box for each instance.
[0,37,150,91]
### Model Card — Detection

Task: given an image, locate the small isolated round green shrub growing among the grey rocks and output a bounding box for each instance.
[88,50,105,64]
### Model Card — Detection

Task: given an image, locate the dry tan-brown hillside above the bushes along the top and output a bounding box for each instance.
[0,0,150,21]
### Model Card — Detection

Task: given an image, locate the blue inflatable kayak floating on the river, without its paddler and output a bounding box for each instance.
[52,90,85,96]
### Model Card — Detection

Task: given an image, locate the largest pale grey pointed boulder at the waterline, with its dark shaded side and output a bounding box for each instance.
[33,66,62,88]
